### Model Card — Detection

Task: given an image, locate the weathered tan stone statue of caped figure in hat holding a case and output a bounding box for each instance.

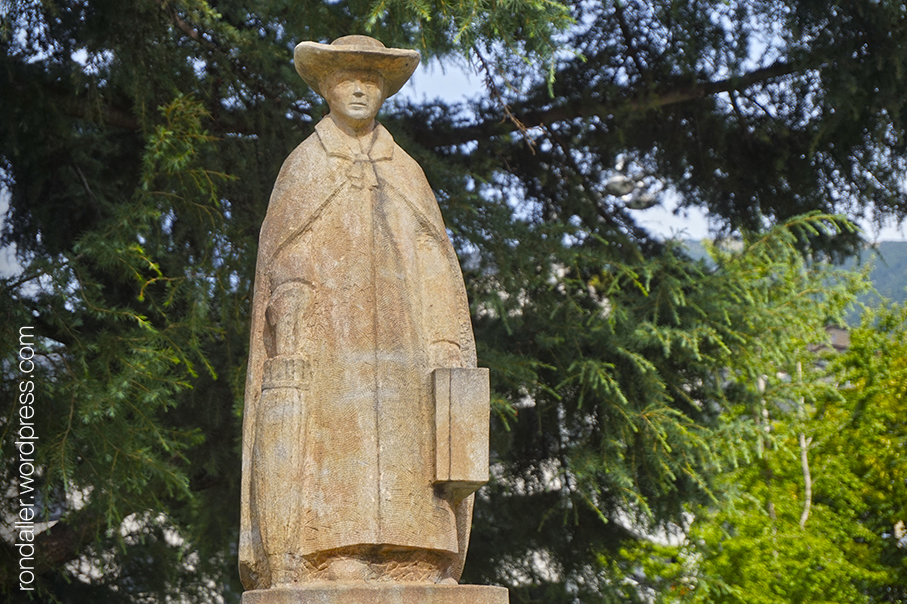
[239,36,507,604]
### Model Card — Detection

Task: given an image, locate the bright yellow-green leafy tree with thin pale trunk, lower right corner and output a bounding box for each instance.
[634,305,907,604]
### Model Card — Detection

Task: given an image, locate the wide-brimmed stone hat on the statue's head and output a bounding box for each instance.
[293,36,422,97]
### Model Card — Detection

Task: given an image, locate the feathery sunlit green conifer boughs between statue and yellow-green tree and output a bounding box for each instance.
[474,218,866,602]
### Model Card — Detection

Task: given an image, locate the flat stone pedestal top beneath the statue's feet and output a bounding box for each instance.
[242,583,510,604]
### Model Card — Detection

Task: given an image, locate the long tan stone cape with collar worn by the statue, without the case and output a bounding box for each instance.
[239,117,476,589]
